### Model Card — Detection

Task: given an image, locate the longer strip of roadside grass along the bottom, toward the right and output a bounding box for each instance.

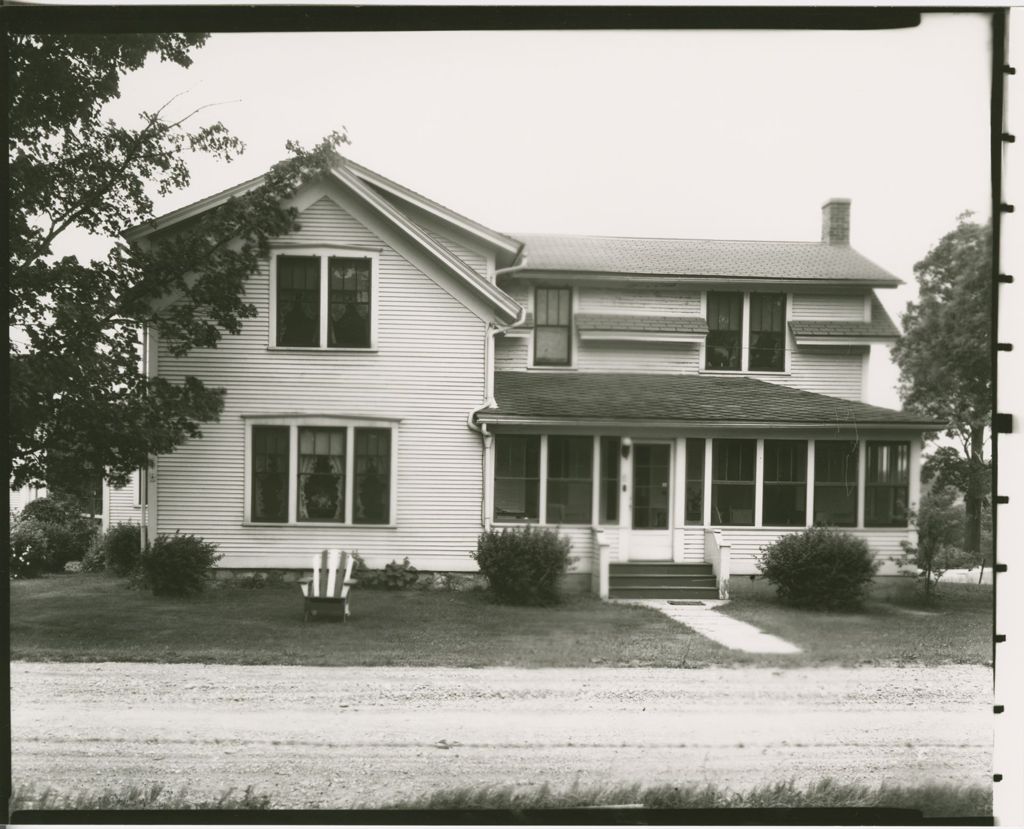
[372,779,992,818]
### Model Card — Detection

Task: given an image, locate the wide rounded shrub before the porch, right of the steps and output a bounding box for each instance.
[757,527,878,610]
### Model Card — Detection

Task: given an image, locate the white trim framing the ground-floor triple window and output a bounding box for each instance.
[242,417,400,530]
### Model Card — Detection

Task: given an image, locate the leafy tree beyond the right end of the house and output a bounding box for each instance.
[893,213,992,553]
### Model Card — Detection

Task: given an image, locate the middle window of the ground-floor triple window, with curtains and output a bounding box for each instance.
[295,428,346,524]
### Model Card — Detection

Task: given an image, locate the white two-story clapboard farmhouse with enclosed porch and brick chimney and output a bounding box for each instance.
[128,161,936,595]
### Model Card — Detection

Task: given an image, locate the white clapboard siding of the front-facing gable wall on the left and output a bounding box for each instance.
[158,191,485,570]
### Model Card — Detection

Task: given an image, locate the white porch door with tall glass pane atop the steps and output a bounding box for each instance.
[630,443,672,561]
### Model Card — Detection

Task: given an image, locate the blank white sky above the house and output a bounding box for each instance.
[49,14,990,406]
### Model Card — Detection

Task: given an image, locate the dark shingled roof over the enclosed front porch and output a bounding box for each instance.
[478,372,945,430]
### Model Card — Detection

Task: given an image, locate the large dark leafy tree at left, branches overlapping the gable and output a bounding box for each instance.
[7,34,347,488]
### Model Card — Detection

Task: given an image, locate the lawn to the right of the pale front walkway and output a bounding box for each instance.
[722,578,993,665]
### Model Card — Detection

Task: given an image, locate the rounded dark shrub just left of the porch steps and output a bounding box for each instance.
[473,525,572,605]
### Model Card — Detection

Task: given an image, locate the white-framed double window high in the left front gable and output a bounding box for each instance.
[270,249,377,350]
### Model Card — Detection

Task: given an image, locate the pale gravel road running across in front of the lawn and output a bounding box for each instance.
[11,662,992,809]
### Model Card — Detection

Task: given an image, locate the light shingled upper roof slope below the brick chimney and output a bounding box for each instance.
[513,233,902,287]
